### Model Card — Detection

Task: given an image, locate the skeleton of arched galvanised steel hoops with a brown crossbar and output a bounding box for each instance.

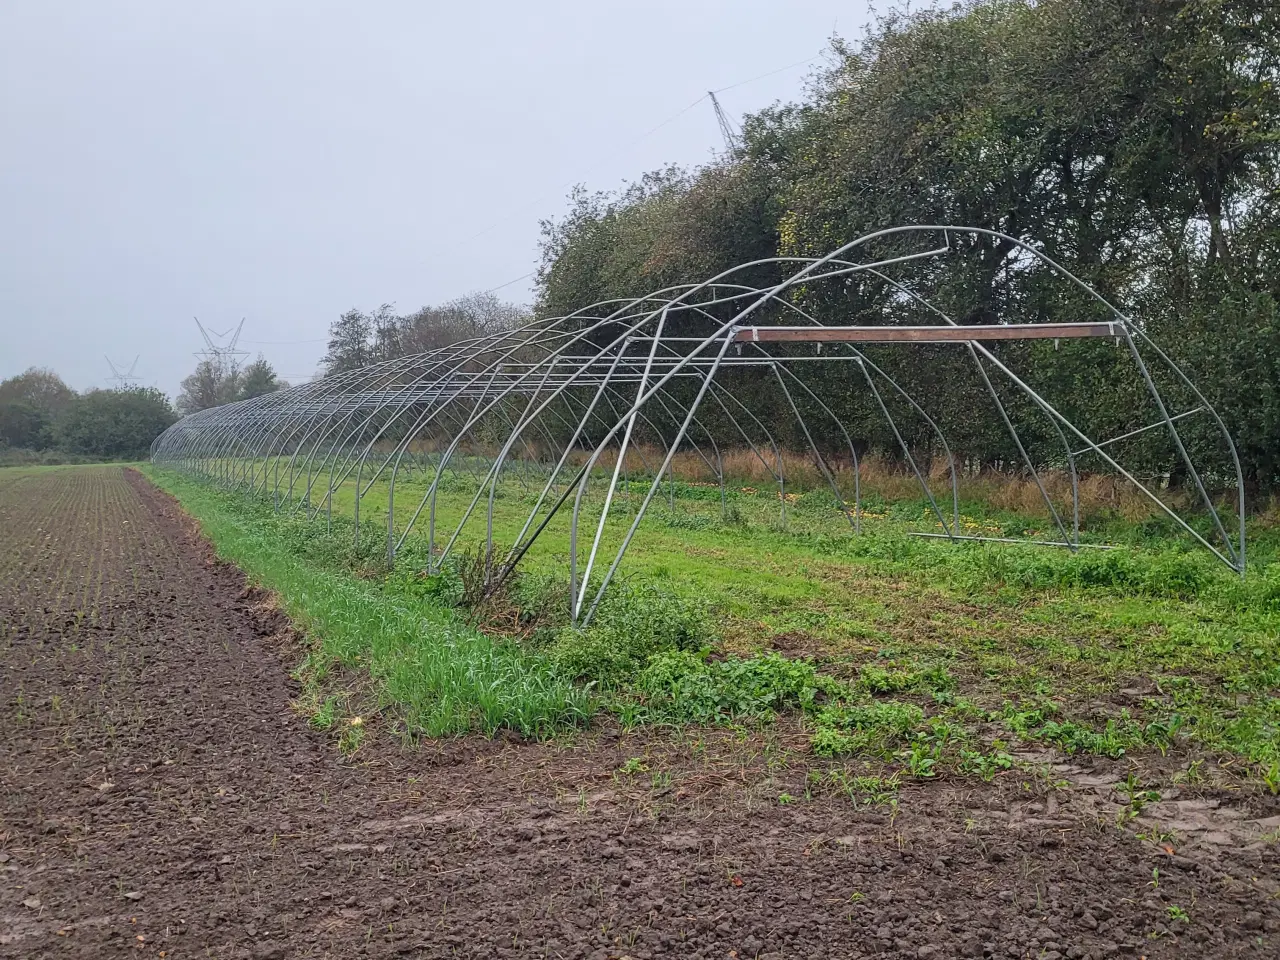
[151,225,1245,623]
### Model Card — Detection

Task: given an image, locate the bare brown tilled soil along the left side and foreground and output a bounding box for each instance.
[0,468,1280,960]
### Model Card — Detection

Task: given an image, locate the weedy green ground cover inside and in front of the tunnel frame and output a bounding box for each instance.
[149,463,1280,780]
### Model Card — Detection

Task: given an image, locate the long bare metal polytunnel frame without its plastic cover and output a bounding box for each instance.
[152,225,1245,625]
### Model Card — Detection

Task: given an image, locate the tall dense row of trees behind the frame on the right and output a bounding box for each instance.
[536,0,1280,490]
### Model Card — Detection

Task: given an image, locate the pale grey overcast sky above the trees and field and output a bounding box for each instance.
[0,0,867,397]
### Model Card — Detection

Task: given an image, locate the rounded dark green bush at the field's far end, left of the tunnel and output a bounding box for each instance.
[55,387,177,460]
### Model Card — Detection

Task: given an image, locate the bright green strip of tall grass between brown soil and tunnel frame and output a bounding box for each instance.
[147,470,594,736]
